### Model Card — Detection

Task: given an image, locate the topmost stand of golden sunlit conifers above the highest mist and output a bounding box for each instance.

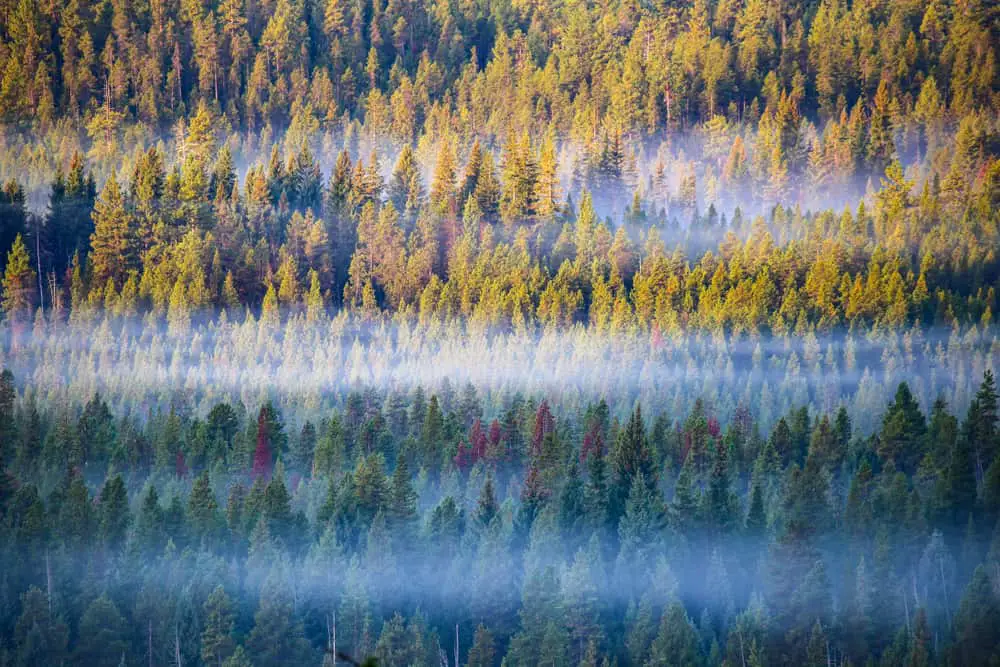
[0,0,998,136]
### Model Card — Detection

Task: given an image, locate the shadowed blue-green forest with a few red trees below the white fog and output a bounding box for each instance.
[0,371,1000,667]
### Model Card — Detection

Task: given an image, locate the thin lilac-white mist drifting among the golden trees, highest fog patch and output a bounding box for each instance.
[7,121,888,241]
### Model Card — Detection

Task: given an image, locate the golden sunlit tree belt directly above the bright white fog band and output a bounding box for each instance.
[0,108,1000,340]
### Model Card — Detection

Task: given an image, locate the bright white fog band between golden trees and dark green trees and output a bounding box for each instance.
[0,313,1000,434]
